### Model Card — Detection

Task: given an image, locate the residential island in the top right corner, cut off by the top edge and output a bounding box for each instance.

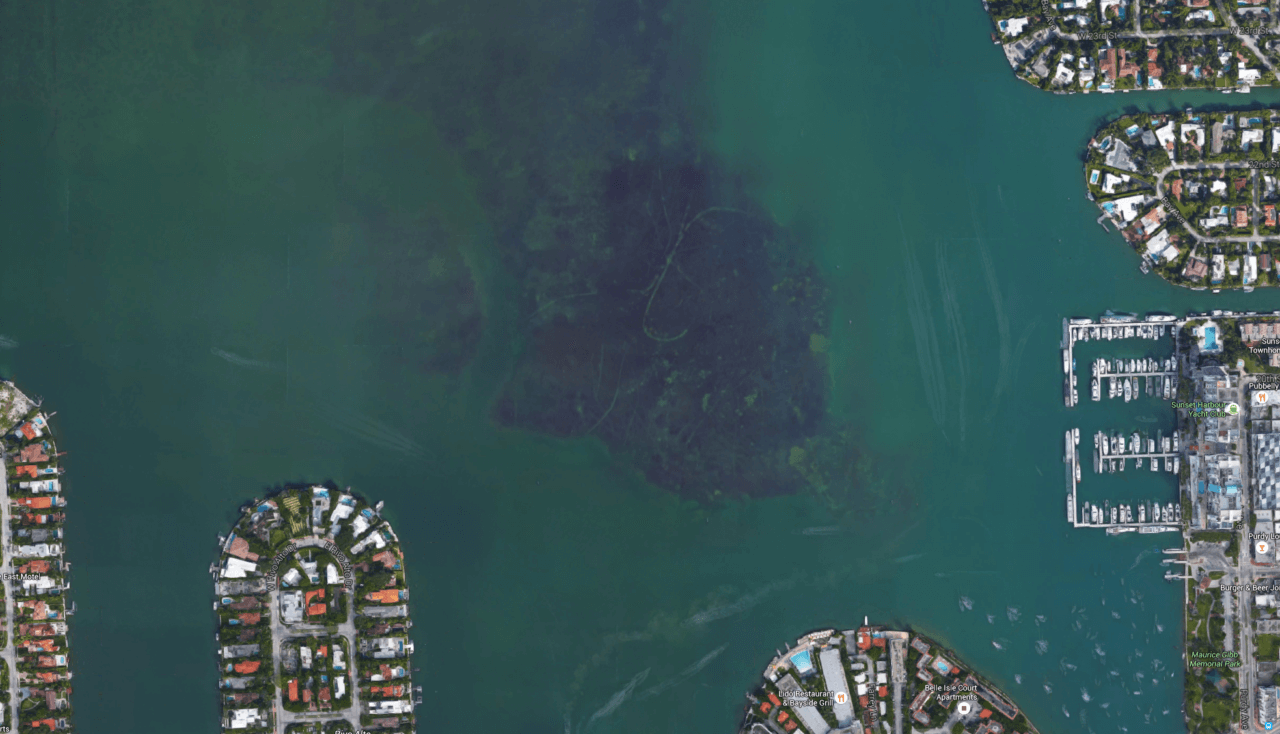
[983,0,1280,94]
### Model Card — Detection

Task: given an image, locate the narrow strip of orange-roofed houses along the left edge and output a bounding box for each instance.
[0,380,76,731]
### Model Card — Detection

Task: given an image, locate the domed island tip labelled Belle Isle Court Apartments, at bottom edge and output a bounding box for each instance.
[739,620,1036,734]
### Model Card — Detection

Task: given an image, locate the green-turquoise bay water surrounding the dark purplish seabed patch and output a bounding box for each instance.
[0,0,1280,734]
